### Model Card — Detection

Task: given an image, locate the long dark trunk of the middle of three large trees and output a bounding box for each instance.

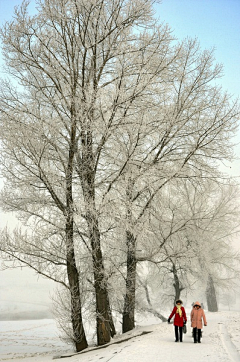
[79,127,113,346]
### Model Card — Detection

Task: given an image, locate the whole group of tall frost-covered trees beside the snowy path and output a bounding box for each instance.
[0,0,239,351]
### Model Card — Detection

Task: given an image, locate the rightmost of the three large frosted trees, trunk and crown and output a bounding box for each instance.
[109,39,239,331]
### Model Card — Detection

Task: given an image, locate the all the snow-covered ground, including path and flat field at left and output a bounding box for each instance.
[0,311,240,362]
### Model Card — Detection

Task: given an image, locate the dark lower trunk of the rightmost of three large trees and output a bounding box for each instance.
[122,231,137,333]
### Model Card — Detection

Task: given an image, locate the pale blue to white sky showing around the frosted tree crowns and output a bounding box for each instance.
[0,0,240,308]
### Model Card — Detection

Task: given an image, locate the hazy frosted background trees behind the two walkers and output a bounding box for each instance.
[139,181,239,320]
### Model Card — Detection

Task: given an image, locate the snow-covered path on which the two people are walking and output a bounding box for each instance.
[0,312,240,362]
